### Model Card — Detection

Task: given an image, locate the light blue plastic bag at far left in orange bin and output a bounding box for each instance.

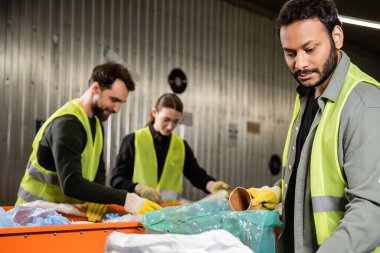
[0,206,71,227]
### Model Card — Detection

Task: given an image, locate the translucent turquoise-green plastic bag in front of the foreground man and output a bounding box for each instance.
[142,199,283,253]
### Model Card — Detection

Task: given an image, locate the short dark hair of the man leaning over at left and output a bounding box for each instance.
[89,62,136,91]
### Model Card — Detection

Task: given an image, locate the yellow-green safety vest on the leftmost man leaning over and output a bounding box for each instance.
[16,99,103,205]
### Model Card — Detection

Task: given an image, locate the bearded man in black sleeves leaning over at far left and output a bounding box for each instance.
[16,62,160,214]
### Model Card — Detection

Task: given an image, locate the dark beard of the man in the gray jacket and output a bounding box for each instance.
[293,40,338,88]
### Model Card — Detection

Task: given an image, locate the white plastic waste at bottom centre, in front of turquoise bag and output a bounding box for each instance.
[105,229,254,253]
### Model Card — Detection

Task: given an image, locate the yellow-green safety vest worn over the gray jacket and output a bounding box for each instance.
[282,63,380,249]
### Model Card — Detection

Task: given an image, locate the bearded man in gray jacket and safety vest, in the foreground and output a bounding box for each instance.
[245,0,380,253]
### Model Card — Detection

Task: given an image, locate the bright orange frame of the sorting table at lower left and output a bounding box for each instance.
[0,207,145,253]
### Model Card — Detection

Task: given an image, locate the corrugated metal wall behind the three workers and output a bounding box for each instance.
[0,0,378,205]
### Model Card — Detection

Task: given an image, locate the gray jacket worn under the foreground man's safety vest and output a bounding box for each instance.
[279,52,380,253]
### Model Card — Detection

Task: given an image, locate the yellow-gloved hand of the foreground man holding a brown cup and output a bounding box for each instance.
[247,186,280,210]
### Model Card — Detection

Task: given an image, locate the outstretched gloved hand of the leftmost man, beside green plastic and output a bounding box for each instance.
[124,193,162,214]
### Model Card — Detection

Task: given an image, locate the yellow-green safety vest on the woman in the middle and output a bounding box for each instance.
[132,127,185,196]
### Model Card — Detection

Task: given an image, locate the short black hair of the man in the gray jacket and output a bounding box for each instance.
[277,0,342,36]
